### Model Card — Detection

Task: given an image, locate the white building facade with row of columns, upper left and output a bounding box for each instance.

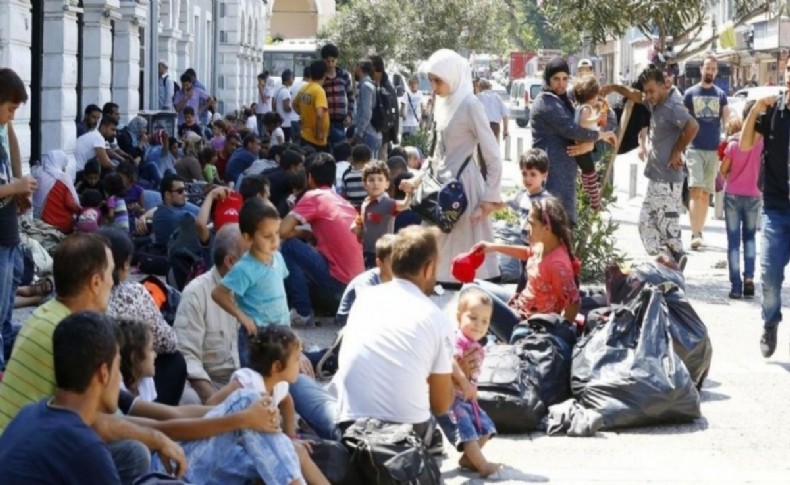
[0,0,272,170]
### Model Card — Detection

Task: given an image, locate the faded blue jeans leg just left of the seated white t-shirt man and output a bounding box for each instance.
[290,374,340,440]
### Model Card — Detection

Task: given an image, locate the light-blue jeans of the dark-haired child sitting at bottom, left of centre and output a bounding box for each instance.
[154,389,302,485]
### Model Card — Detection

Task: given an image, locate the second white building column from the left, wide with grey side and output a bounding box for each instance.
[41,2,79,154]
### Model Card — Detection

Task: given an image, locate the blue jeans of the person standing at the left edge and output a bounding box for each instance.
[0,244,25,370]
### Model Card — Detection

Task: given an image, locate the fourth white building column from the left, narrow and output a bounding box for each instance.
[112,2,148,124]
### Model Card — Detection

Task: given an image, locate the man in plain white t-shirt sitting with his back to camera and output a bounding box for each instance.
[333,226,456,432]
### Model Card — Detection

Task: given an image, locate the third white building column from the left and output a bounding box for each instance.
[82,0,120,106]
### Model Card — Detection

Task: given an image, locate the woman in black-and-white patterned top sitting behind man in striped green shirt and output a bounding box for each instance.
[98,227,187,406]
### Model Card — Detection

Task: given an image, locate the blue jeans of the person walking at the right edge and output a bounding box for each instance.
[760,210,790,328]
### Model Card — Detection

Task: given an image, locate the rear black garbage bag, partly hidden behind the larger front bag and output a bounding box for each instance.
[608,263,713,389]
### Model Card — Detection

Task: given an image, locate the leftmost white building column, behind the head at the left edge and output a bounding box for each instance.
[0,0,33,165]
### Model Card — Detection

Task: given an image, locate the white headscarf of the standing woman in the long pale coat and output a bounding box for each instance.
[420,49,474,130]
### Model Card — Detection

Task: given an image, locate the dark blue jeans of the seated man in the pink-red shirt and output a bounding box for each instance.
[280,238,346,317]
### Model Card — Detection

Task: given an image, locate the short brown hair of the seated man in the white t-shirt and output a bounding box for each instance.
[392,226,439,278]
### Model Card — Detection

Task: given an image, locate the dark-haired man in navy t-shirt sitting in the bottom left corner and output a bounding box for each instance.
[0,312,132,485]
